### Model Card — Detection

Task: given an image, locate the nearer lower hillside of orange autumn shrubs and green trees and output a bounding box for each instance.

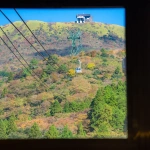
[0,47,127,139]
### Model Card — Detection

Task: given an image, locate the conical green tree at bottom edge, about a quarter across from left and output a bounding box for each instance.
[29,123,41,139]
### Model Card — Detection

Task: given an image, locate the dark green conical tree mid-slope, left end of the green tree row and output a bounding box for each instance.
[50,100,62,116]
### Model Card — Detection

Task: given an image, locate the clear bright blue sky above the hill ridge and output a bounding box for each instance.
[0,8,125,26]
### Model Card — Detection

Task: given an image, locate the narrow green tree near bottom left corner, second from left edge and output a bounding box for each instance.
[7,115,17,134]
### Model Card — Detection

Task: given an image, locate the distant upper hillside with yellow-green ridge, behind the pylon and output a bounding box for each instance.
[0,21,125,71]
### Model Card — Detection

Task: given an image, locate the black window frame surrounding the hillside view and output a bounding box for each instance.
[0,0,150,150]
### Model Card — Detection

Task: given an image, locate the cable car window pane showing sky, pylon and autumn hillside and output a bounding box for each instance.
[0,8,128,139]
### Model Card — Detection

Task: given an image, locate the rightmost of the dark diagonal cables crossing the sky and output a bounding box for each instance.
[14,8,59,67]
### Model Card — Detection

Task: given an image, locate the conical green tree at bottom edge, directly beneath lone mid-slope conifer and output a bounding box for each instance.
[45,125,59,139]
